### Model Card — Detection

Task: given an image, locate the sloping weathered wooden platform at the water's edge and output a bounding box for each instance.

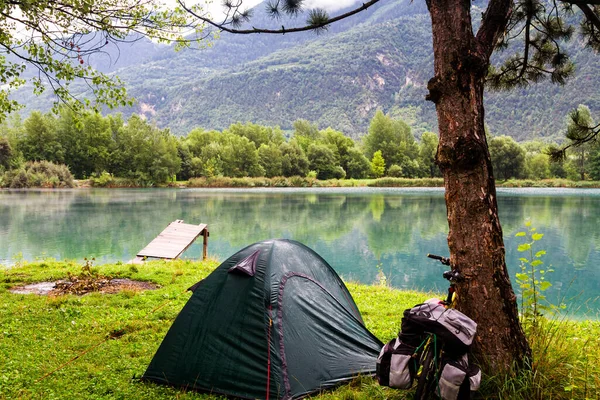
[131,220,208,263]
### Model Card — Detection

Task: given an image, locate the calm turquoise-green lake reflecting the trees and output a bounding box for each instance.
[0,188,600,315]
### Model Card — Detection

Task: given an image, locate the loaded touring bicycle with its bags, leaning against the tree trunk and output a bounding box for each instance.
[376,254,481,400]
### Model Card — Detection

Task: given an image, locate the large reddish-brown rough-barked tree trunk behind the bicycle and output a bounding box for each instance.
[427,0,531,372]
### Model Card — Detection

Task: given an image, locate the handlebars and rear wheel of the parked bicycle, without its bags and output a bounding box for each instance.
[414,254,464,400]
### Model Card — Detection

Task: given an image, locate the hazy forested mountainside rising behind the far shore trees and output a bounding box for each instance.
[11,0,600,140]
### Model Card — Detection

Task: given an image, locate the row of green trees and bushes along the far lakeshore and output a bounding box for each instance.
[0,106,600,187]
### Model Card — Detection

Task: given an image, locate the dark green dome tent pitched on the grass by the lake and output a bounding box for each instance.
[142,240,382,399]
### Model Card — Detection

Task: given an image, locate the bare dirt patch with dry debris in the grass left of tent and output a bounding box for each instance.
[10,278,159,295]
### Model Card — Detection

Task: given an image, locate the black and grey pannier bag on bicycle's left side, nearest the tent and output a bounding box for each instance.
[376,338,416,389]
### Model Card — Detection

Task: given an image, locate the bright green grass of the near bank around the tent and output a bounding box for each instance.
[0,261,600,400]
